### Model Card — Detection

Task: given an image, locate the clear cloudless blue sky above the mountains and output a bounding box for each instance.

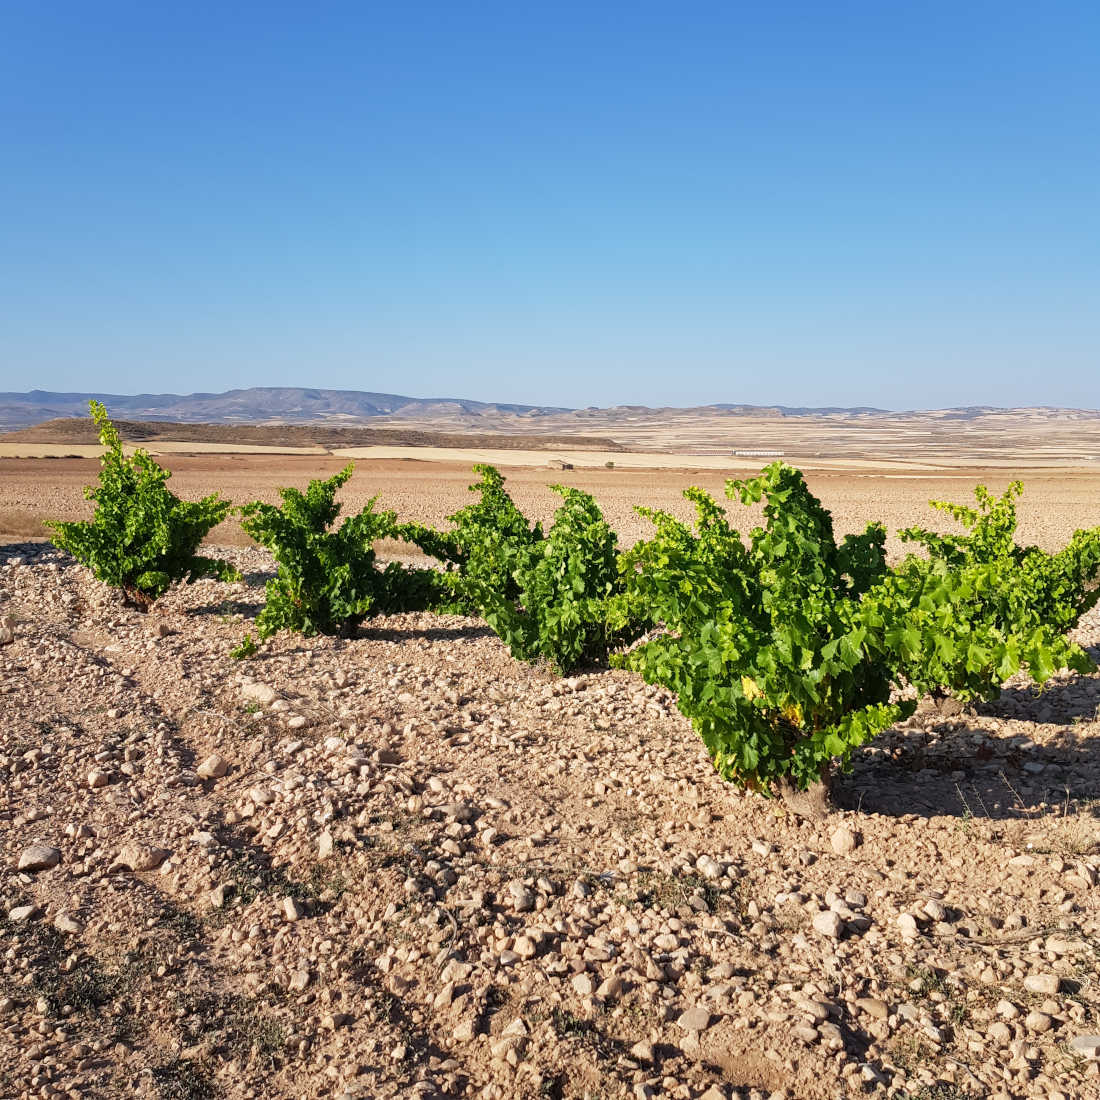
[0,0,1100,408]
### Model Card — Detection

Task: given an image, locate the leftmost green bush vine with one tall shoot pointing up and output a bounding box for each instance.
[48,400,238,611]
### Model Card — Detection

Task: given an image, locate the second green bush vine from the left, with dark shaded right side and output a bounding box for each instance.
[233,465,440,657]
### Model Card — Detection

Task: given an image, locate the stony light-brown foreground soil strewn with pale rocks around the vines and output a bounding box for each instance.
[0,545,1100,1100]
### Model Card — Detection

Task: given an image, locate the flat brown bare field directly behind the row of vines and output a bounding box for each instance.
[0,449,1100,554]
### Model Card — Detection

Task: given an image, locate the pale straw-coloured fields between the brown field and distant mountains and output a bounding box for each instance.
[10,403,1100,473]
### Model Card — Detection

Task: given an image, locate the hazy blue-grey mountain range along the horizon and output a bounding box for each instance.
[0,386,1100,431]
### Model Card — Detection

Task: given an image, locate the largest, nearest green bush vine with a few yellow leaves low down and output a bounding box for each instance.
[613,463,914,794]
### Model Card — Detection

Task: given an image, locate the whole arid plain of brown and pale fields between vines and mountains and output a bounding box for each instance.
[0,408,1100,551]
